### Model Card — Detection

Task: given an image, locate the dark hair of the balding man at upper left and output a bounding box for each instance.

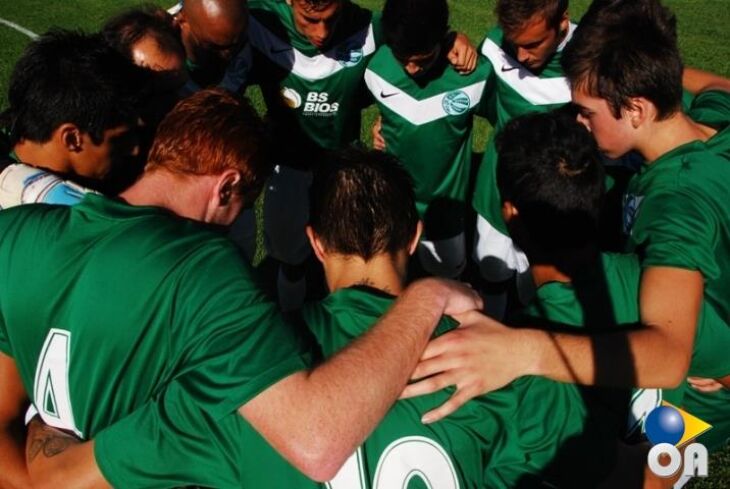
[102,5,185,59]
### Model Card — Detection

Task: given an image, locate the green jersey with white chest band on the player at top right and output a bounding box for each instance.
[472,23,576,264]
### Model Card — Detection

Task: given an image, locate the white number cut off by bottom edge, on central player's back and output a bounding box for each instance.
[327,436,459,489]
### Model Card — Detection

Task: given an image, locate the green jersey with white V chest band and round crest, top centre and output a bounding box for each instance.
[365,46,489,239]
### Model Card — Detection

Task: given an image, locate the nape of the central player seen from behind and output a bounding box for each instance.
[324,253,406,295]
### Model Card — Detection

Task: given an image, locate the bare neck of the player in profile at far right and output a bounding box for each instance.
[636,112,710,163]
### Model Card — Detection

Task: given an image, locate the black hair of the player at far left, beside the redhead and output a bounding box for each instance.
[5,30,147,145]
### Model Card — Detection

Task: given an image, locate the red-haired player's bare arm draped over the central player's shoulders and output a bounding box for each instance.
[239,279,481,481]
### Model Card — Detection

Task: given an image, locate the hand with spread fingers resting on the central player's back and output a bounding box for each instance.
[401,311,526,423]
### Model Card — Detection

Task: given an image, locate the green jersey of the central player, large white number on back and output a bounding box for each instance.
[235,288,620,489]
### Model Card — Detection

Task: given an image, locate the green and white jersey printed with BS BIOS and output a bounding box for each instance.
[249,0,381,168]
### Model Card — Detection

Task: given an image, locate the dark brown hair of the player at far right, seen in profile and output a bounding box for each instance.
[561,0,684,120]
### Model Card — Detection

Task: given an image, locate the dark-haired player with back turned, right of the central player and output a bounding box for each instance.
[497,111,730,444]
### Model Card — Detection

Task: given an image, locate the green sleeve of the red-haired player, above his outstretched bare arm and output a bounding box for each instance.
[170,240,309,418]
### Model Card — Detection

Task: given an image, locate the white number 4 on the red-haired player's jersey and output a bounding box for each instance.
[33,328,83,438]
